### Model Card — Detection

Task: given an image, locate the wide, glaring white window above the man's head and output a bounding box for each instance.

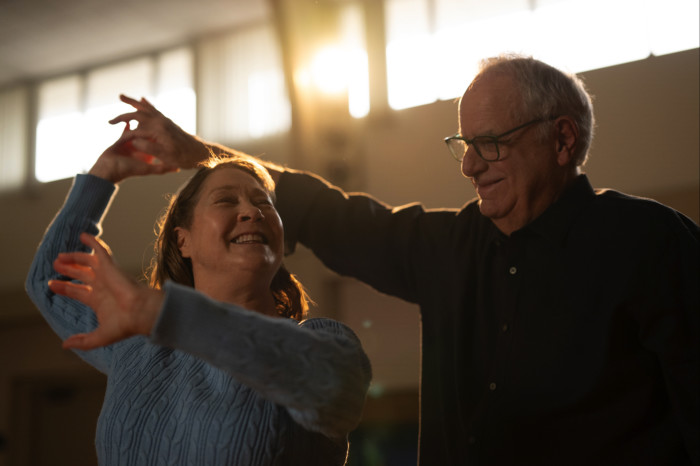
[385,0,700,109]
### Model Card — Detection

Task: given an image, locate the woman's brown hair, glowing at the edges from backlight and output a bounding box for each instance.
[148,153,309,321]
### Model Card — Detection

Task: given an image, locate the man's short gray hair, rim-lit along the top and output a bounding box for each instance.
[474,54,595,166]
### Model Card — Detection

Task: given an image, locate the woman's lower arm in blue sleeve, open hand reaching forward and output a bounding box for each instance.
[51,234,371,438]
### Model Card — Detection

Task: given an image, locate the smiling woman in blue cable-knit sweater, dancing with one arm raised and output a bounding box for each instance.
[26,137,371,466]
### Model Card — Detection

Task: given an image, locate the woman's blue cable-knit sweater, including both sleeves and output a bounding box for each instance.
[26,175,371,466]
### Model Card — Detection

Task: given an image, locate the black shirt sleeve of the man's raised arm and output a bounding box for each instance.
[276,170,456,303]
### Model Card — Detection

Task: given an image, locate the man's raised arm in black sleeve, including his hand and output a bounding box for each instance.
[106,96,455,302]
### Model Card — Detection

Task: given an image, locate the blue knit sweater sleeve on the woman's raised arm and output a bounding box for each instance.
[25,175,117,373]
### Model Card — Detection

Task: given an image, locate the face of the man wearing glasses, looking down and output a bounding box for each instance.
[459,73,562,234]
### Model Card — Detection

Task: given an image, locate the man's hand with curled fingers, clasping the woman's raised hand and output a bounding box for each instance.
[110,95,211,168]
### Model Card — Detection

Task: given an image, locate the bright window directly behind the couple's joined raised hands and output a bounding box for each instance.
[35,48,196,182]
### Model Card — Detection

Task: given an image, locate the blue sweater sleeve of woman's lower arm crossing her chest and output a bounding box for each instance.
[151,282,371,438]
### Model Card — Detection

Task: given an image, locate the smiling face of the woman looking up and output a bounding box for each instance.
[175,166,284,286]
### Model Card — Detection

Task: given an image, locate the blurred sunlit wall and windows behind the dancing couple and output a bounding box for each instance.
[0,0,700,466]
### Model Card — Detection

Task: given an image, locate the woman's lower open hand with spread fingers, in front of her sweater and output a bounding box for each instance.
[49,233,163,350]
